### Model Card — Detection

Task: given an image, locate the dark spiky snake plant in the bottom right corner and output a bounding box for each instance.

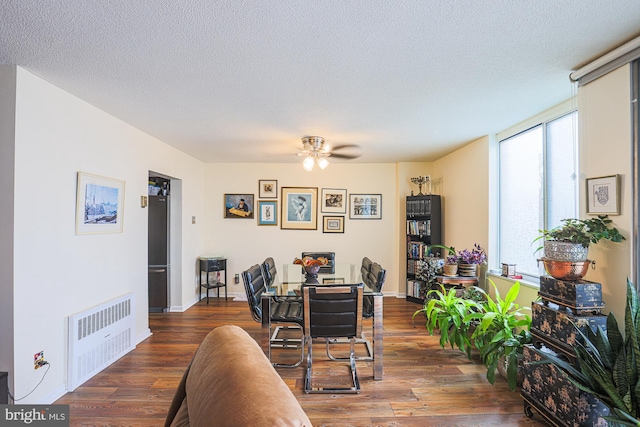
[537,280,640,426]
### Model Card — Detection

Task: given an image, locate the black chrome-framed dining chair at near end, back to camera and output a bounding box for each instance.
[302,283,364,393]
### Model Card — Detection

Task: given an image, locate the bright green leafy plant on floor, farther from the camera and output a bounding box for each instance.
[411,285,480,356]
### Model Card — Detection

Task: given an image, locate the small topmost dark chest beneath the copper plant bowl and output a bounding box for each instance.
[538,276,604,312]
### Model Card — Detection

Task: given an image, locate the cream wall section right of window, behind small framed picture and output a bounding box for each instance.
[578,65,633,324]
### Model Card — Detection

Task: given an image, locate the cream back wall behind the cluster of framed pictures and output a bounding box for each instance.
[203,162,404,295]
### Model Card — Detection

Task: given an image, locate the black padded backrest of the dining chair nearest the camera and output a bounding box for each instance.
[302,283,364,338]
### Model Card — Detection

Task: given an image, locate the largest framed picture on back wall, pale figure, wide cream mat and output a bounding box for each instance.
[280,187,318,230]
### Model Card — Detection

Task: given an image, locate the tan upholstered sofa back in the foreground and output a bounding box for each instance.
[165,325,311,427]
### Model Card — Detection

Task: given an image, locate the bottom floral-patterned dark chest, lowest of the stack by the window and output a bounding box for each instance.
[520,345,609,427]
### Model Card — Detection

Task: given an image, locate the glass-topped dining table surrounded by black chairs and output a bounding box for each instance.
[261,263,383,380]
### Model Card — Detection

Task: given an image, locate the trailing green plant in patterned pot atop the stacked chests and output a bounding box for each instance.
[534,215,625,262]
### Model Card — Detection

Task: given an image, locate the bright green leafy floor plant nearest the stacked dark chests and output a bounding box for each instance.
[464,280,531,390]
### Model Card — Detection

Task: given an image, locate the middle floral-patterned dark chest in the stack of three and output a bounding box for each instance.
[531,301,607,363]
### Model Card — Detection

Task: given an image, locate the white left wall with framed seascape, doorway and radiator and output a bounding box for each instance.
[13,68,204,403]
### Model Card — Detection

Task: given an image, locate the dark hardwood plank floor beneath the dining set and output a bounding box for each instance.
[55,298,545,427]
